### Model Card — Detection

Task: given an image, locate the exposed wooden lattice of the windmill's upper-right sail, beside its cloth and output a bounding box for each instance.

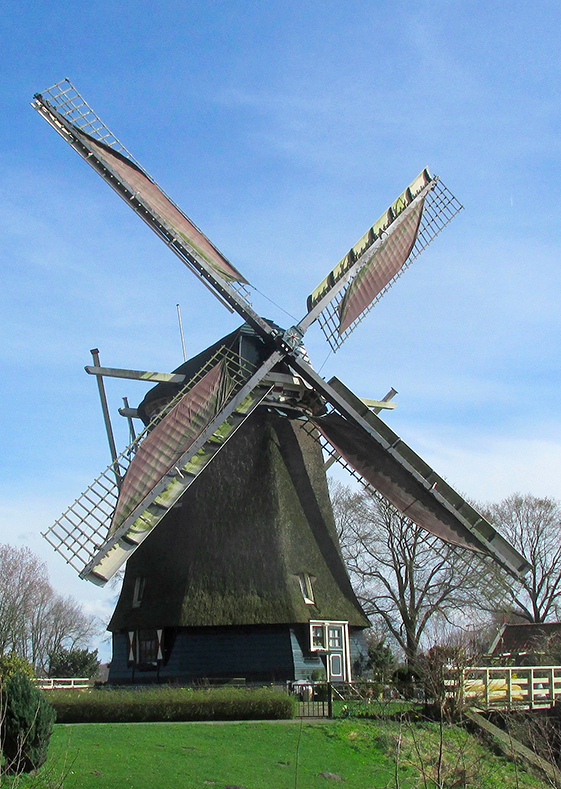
[317,179,463,352]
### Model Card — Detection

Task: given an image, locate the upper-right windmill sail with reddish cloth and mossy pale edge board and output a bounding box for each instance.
[300,169,462,351]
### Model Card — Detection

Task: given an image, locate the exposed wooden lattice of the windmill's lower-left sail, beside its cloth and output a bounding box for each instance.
[42,348,254,575]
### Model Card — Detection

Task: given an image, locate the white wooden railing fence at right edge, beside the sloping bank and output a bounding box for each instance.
[446,666,561,709]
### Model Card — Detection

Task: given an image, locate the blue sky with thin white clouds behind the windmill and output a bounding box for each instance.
[0,0,561,652]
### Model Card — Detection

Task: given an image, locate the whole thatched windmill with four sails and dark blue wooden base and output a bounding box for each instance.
[33,80,527,682]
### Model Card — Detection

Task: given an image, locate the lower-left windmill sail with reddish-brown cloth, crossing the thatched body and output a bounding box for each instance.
[43,349,281,585]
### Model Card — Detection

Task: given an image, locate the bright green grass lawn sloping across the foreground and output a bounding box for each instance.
[24,720,543,789]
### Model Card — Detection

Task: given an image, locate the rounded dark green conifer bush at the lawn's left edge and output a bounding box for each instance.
[0,671,56,773]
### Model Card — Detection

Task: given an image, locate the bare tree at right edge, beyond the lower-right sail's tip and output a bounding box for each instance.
[481,493,561,622]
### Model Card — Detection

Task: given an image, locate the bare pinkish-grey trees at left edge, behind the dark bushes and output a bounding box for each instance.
[0,545,100,670]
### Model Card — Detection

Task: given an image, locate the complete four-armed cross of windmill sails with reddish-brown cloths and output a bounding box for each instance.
[33,80,527,596]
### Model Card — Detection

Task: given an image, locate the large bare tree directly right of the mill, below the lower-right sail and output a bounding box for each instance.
[332,483,494,669]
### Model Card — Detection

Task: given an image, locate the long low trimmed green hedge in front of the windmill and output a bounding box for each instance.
[47,687,295,723]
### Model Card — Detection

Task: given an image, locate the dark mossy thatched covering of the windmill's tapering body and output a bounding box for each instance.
[109,408,369,630]
